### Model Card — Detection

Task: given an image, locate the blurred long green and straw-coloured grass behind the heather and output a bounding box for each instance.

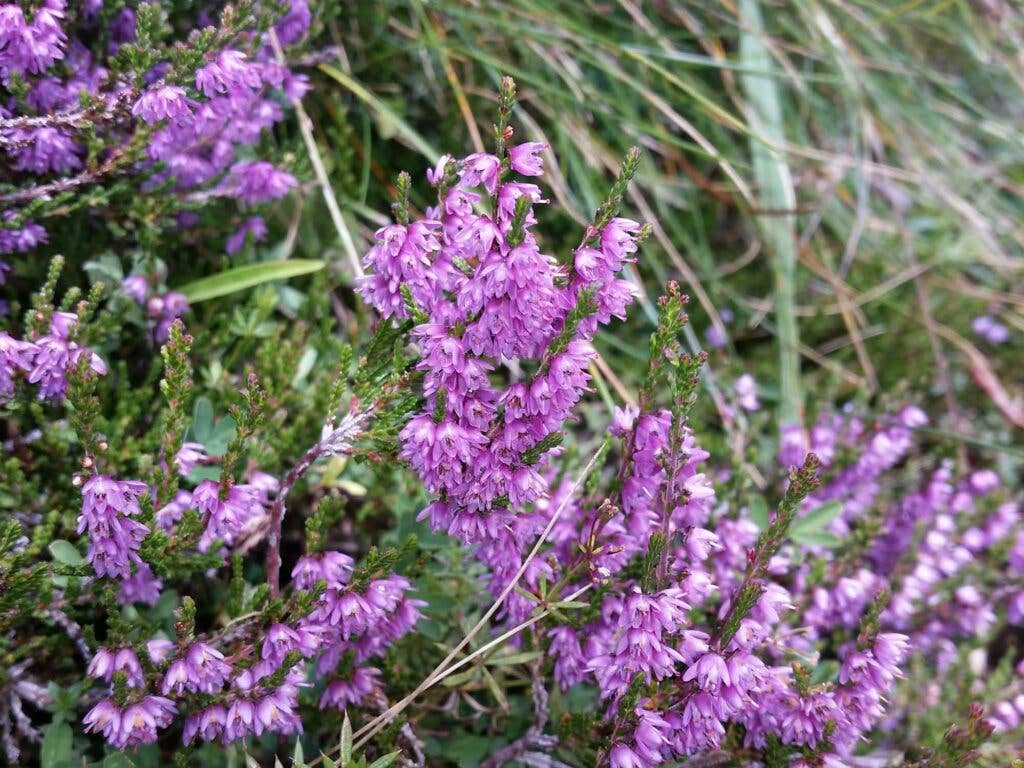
[280,0,1024,460]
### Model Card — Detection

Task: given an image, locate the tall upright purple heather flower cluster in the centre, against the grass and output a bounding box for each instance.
[361,85,641,620]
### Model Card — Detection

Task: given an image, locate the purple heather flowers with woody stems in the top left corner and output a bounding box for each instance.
[0,0,311,282]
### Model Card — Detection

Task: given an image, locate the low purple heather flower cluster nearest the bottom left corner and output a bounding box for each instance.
[83,544,424,749]
